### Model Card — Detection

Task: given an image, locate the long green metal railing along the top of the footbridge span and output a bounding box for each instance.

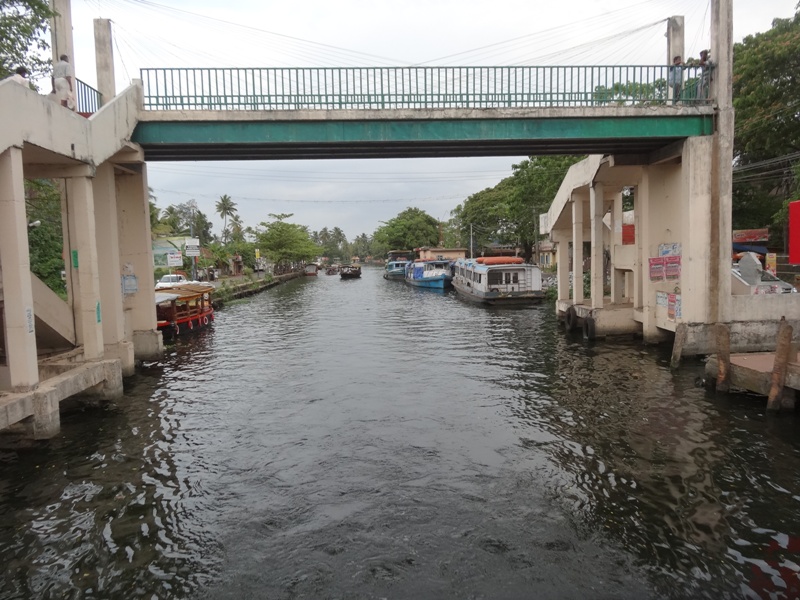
[141,65,711,110]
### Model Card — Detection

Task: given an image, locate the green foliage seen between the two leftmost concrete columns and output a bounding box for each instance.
[25,179,67,298]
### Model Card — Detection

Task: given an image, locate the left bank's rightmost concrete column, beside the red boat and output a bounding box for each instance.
[116,163,164,360]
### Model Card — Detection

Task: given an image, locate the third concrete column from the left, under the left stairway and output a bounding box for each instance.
[94,163,134,377]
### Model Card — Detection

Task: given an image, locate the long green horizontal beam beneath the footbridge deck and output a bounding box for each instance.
[133,115,714,161]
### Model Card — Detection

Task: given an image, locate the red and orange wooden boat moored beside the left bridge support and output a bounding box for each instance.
[155,283,214,340]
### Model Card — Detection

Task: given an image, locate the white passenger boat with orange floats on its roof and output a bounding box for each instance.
[453,256,545,306]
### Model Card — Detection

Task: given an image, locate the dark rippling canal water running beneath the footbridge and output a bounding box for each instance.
[0,268,800,599]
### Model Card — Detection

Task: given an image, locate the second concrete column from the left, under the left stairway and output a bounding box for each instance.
[67,177,103,360]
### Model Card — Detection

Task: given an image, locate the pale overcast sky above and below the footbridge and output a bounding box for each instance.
[65,0,797,240]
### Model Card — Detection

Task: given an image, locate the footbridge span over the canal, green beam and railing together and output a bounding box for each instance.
[132,65,714,161]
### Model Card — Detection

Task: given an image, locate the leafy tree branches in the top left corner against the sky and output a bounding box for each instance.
[0,0,53,79]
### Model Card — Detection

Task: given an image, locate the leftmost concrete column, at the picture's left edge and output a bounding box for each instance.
[0,147,39,392]
